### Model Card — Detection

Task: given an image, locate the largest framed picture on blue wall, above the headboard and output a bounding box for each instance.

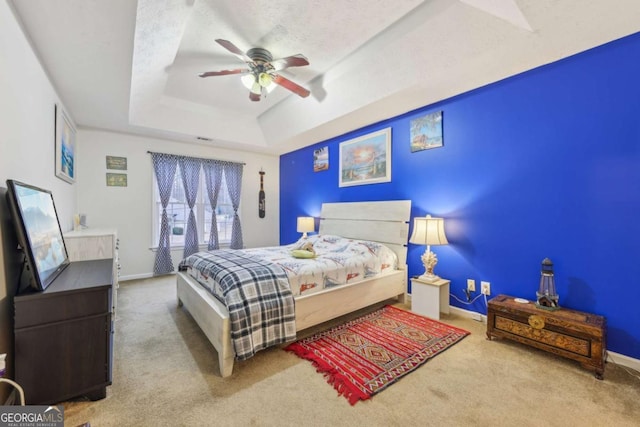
[339,128,391,187]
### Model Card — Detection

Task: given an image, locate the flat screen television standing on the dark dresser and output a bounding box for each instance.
[7,179,69,291]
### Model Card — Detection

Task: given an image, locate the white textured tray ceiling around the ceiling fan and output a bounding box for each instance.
[10,0,640,154]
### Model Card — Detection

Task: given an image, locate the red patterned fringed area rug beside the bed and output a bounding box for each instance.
[285,305,469,405]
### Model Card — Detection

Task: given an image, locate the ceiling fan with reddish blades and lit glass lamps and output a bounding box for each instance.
[199,39,311,101]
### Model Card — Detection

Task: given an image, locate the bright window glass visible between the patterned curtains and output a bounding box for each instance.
[152,165,233,248]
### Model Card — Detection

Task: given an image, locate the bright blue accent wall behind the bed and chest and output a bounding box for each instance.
[280,33,640,358]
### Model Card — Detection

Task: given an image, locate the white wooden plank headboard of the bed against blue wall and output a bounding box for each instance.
[319,200,411,268]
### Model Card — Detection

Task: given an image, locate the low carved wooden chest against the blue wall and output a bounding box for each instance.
[487,295,606,379]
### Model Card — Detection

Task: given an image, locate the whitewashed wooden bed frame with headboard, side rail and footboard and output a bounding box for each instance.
[176,200,411,377]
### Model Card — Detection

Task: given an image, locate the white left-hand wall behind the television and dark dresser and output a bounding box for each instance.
[0,0,77,402]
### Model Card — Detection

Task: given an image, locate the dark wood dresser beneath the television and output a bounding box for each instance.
[14,259,113,405]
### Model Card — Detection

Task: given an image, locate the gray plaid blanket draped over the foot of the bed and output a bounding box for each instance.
[180,249,296,360]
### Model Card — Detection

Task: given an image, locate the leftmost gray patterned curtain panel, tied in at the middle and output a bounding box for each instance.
[151,153,178,274]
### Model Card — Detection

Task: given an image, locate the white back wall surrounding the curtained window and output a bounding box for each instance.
[77,129,280,280]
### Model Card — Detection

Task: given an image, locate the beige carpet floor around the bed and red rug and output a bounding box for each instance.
[64,276,640,427]
